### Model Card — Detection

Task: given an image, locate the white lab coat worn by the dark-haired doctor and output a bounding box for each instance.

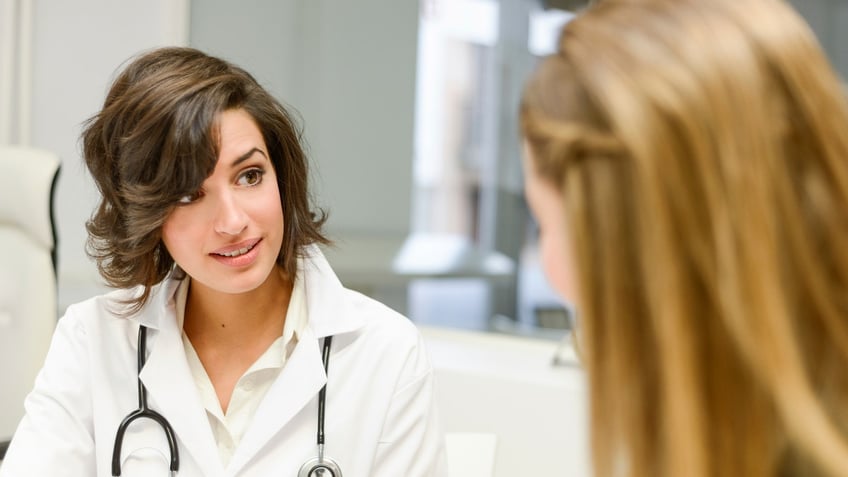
[0,247,445,477]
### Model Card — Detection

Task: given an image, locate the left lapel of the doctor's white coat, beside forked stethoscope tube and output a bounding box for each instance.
[135,278,223,476]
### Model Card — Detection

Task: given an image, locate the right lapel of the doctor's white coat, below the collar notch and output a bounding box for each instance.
[228,330,327,474]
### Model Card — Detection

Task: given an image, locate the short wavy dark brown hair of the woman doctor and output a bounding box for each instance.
[82,47,328,310]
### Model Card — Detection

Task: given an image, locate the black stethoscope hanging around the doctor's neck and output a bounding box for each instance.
[112,325,342,477]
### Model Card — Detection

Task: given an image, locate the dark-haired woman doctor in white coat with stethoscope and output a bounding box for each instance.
[0,48,444,477]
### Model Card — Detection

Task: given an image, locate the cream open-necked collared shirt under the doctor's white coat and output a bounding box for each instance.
[175,277,308,467]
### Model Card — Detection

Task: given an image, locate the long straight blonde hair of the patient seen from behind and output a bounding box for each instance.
[521,0,848,477]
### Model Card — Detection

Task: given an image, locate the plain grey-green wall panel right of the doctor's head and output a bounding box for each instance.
[190,0,418,239]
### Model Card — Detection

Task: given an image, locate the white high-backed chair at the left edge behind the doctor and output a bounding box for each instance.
[0,146,60,460]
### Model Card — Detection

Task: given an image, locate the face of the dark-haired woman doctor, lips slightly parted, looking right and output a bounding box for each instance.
[162,109,283,294]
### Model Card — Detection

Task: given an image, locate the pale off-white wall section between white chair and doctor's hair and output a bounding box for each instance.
[32,0,188,308]
